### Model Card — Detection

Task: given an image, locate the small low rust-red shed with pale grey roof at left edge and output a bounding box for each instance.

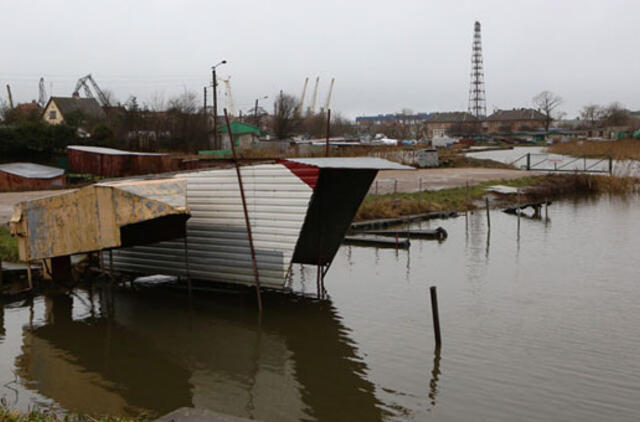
[0,163,65,191]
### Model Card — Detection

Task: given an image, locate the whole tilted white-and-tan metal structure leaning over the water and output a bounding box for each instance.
[12,158,412,289]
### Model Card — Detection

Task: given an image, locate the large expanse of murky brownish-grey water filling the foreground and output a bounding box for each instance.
[0,197,640,421]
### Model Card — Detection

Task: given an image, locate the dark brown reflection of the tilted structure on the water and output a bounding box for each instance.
[12,288,382,421]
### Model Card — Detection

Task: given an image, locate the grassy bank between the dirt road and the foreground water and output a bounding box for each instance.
[356,174,640,220]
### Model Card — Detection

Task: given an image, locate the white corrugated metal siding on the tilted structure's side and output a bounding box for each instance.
[113,164,313,288]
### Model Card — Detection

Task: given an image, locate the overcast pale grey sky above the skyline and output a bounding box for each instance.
[0,0,640,117]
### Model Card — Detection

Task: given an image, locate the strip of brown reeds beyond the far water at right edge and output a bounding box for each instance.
[548,139,640,160]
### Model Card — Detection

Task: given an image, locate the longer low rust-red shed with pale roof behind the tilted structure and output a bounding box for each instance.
[67,145,179,177]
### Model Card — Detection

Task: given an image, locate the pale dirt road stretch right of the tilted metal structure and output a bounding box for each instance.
[369,167,535,194]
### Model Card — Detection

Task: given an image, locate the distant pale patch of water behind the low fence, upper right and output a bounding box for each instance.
[466,147,640,176]
